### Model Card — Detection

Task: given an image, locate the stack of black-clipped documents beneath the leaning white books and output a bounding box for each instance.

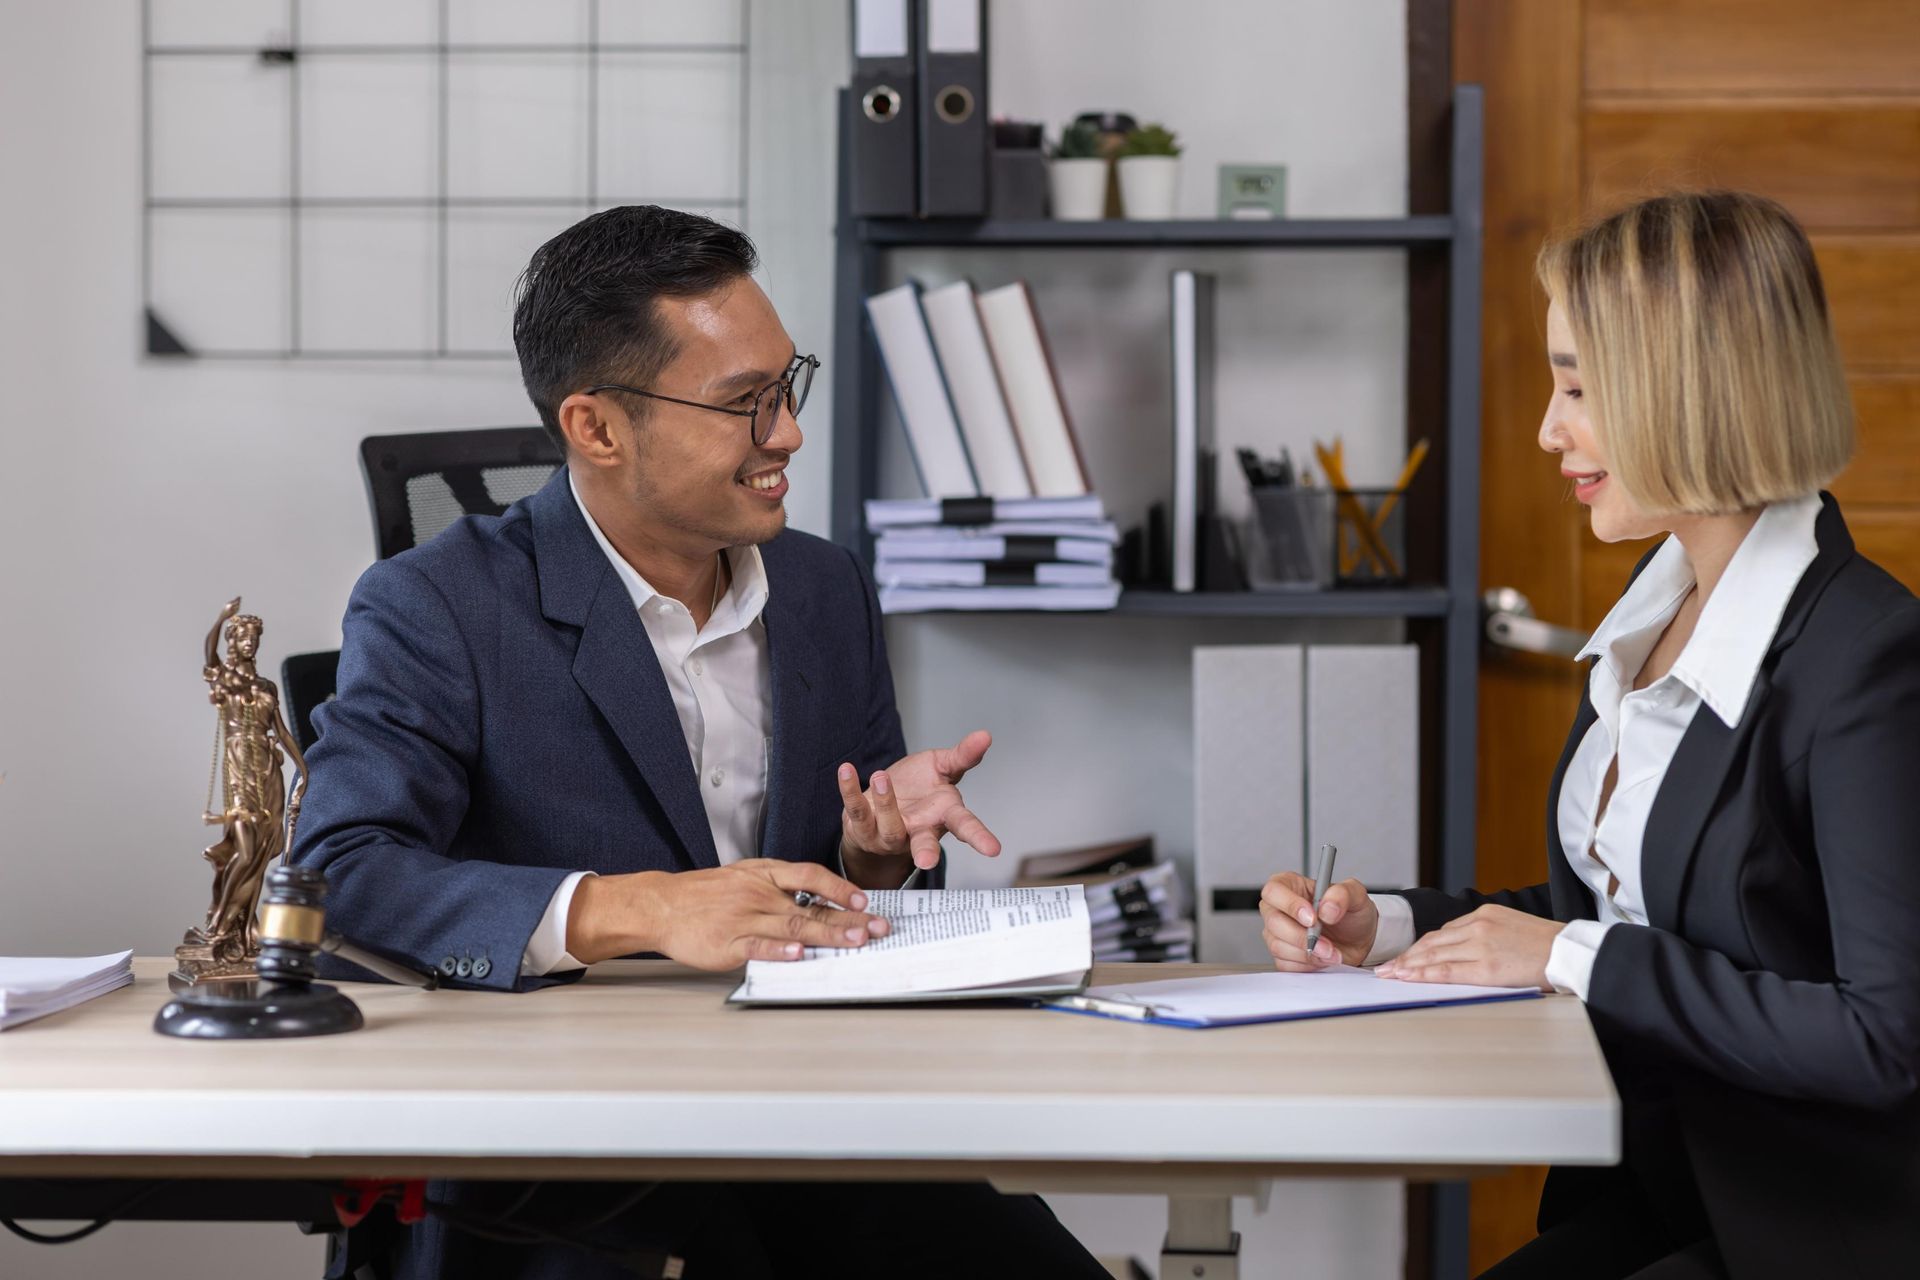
[866,495,1119,614]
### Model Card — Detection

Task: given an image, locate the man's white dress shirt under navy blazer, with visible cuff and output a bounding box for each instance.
[520,476,774,977]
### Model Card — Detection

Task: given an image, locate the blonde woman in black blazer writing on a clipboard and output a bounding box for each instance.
[1261,192,1920,1280]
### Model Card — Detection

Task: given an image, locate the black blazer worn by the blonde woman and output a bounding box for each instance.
[1407,495,1920,1278]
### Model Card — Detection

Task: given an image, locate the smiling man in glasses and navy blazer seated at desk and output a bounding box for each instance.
[296,207,1106,1278]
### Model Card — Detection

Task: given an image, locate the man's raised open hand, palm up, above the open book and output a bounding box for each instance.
[839,729,1000,887]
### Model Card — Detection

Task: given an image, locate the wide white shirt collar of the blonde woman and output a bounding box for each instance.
[1580,495,1820,727]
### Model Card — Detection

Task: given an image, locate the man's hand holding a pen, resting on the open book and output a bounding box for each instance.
[566,858,889,969]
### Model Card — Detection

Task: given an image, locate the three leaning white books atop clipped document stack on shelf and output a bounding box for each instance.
[866,280,1119,612]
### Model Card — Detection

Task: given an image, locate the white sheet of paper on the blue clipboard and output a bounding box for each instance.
[1087,965,1515,1023]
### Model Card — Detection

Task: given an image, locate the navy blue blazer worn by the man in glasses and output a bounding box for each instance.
[294,468,906,990]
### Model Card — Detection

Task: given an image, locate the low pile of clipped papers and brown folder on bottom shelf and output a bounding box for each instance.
[1014,835,1194,963]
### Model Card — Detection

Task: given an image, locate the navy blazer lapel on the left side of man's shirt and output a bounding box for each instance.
[528,468,720,867]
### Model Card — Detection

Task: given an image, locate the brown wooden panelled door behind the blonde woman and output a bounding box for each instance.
[1453,0,1920,1272]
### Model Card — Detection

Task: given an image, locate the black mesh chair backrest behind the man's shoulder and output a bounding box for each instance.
[361,426,563,560]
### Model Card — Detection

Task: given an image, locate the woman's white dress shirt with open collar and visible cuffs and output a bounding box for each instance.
[1367,495,1820,1000]
